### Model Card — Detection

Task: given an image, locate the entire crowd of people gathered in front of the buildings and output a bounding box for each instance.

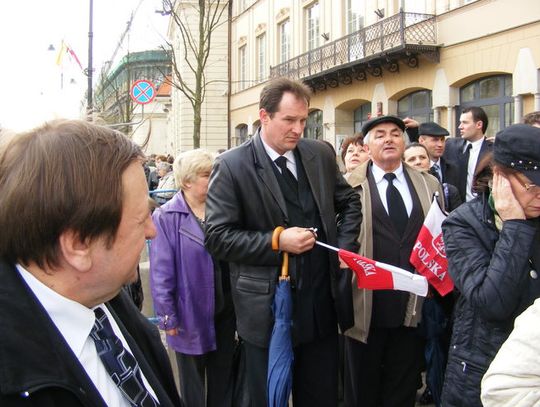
[0,78,540,407]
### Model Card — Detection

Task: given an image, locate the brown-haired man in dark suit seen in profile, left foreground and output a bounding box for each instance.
[0,120,181,407]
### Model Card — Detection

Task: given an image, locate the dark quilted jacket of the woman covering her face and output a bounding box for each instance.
[442,195,540,407]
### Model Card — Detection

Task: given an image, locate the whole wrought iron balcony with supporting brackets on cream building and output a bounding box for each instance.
[270,12,439,90]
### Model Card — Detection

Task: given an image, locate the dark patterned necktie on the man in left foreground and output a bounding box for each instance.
[90,308,159,407]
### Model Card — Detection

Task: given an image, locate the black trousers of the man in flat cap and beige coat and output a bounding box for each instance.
[344,327,423,407]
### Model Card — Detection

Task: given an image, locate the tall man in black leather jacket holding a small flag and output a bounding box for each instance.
[206,78,362,407]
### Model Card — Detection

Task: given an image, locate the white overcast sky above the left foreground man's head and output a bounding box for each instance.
[0,0,168,130]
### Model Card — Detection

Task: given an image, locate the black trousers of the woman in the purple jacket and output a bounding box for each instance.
[176,299,236,407]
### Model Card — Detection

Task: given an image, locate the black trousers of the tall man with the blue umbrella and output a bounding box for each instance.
[244,327,338,407]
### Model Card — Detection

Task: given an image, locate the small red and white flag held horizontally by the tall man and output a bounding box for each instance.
[338,249,428,297]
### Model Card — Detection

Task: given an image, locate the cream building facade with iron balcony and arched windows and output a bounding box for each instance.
[230,0,540,148]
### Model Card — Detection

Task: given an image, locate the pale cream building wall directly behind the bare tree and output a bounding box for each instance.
[167,0,229,156]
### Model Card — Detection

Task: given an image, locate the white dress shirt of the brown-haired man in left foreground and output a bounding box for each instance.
[17,264,157,407]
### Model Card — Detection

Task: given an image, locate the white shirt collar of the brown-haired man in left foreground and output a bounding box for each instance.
[17,264,95,358]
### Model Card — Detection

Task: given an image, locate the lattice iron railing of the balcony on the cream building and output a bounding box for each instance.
[270,12,437,79]
